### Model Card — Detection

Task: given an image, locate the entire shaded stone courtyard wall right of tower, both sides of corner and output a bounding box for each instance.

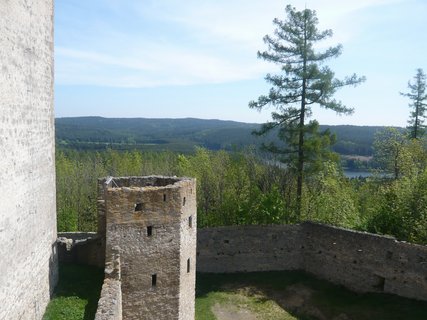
[197,223,427,301]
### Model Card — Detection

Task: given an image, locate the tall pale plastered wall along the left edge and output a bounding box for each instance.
[0,0,57,319]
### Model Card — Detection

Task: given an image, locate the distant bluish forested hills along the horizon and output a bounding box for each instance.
[55,117,402,156]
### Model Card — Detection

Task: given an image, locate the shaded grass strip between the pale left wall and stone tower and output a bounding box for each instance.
[43,265,104,320]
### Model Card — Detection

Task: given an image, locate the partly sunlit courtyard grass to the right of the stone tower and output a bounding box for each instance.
[196,272,427,320]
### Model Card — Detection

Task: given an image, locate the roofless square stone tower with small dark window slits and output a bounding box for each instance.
[99,176,197,320]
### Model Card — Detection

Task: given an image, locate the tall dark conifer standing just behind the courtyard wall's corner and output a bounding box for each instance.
[249,5,364,214]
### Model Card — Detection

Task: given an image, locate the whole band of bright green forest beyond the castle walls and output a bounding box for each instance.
[56,129,427,244]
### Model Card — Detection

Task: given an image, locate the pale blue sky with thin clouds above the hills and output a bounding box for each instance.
[55,0,427,126]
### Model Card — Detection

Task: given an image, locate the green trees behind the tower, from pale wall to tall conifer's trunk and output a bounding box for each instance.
[56,148,295,231]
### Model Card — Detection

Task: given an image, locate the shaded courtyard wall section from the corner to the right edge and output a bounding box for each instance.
[302,223,427,300]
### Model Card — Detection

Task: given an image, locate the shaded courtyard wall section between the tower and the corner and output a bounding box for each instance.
[197,225,302,273]
